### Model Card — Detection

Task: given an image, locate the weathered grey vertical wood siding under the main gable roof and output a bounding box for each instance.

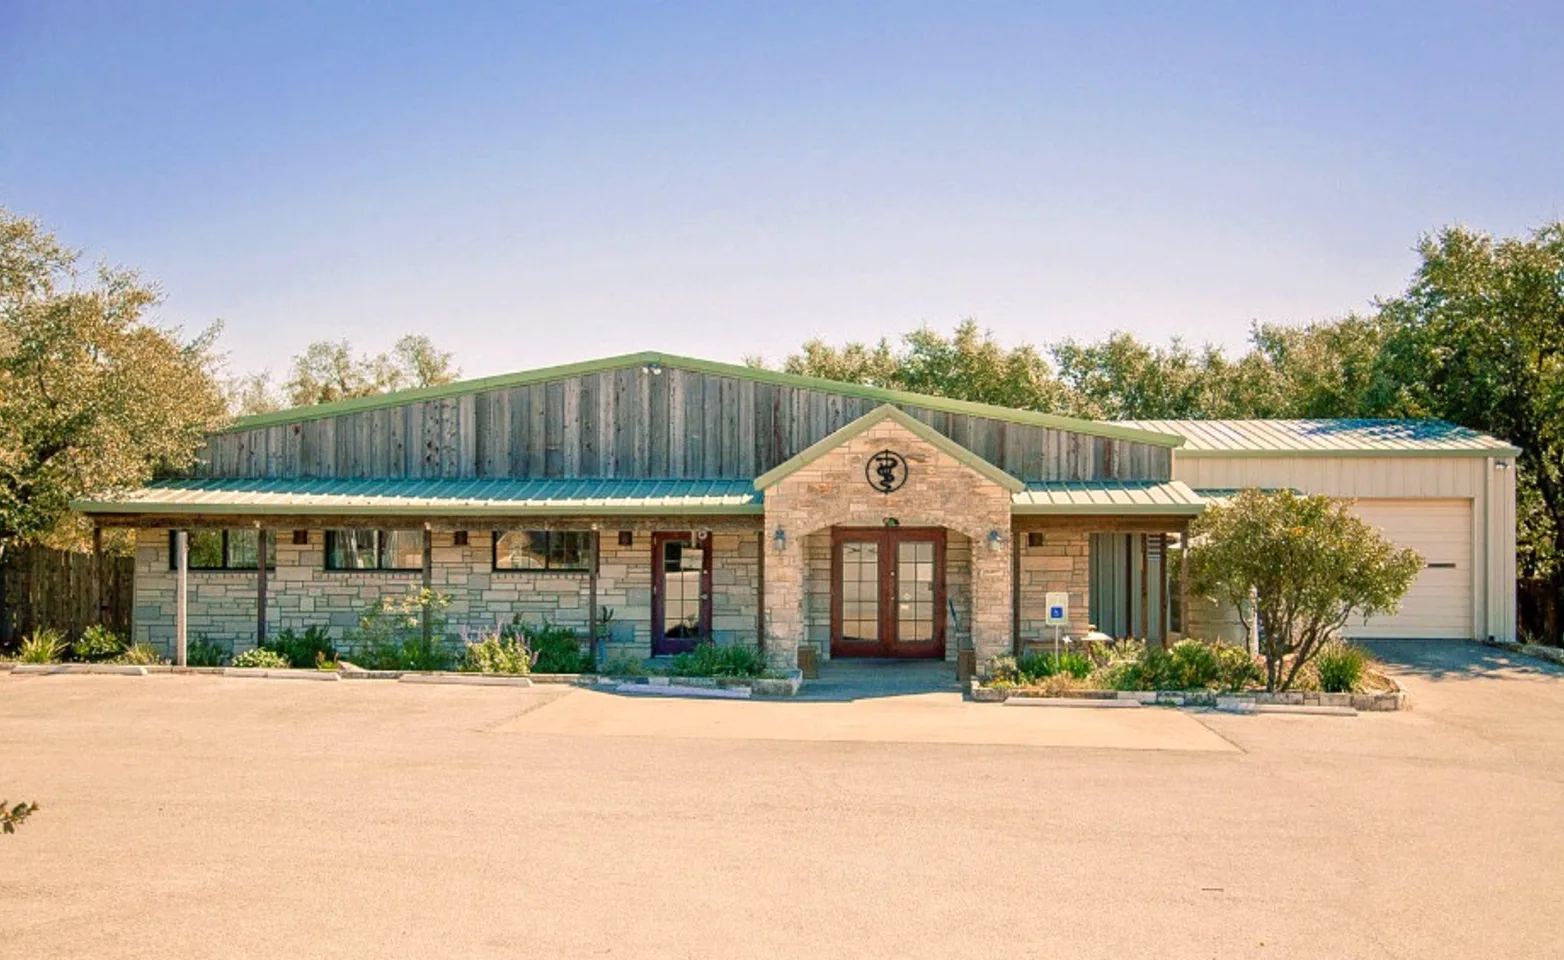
[200,367,1173,482]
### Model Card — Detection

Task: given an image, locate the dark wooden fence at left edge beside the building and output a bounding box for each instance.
[0,547,136,647]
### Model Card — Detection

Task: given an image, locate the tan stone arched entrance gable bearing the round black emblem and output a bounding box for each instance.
[765,419,1010,666]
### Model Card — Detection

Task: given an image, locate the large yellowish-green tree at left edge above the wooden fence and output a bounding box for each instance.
[0,208,225,558]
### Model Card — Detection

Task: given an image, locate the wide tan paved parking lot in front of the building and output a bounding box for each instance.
[0,646,1564,958]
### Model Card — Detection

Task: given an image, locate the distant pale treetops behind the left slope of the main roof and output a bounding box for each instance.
[281,333,461,407]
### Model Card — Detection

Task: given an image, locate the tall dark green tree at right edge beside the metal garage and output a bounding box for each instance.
[1370,220,1564,643]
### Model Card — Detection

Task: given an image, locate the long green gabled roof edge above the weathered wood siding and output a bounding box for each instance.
[225,350,1184,447]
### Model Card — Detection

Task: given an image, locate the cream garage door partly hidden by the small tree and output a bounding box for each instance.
[1343,500,1472,639]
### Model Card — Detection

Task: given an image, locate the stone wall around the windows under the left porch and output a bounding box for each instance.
[131,530,759,657]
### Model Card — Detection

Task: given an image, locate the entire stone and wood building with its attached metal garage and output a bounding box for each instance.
[78,353,1516,664]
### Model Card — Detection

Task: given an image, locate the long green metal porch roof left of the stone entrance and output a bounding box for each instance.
[72,477,763,516]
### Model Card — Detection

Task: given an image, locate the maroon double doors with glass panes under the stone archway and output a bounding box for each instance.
[830,527,945,658]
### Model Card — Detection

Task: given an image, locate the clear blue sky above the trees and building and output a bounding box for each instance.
[0,0,1564,375]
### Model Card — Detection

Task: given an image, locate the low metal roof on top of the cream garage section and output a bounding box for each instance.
[1125,419,1520,458]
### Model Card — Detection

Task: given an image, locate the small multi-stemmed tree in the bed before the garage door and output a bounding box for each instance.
[1189,489,1423,691]
